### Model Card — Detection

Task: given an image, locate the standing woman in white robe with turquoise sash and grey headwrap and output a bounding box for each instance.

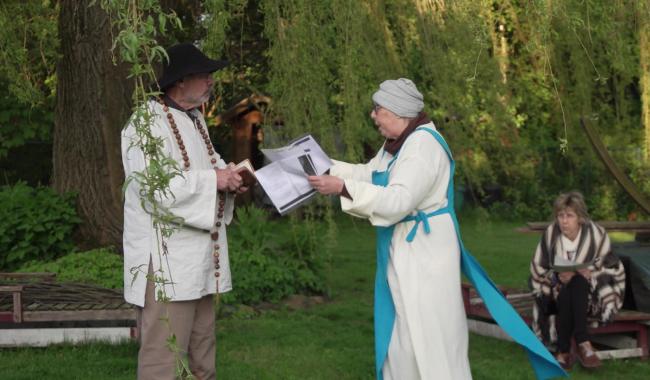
[309,78,565,380]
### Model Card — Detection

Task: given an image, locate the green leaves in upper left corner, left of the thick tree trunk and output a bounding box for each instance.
[0,0,58,159]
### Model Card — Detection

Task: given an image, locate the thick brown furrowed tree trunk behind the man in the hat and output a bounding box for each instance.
[53,0,133,247]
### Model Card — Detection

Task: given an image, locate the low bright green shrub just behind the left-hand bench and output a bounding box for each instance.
[18,248,124,289]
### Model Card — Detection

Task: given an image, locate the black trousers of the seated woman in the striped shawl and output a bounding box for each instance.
[556,273,589,352]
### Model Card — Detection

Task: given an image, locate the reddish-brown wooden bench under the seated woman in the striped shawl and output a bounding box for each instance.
[462,283,650,359]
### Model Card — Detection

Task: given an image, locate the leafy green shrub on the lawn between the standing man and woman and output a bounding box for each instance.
[223,207,326,304]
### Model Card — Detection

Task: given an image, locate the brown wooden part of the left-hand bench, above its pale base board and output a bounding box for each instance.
[0,273,136,327]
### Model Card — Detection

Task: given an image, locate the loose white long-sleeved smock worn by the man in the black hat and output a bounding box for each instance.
[121,101,234,306]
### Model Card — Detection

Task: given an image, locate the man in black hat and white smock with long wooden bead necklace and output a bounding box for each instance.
[122,44,247,380]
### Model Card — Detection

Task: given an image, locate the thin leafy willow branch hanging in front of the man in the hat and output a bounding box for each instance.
[92,0,193,379]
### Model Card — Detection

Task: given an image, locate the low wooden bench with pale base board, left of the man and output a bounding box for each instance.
[0,273,137,346]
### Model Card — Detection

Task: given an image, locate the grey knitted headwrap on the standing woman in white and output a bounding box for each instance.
[372,78,424,118]
